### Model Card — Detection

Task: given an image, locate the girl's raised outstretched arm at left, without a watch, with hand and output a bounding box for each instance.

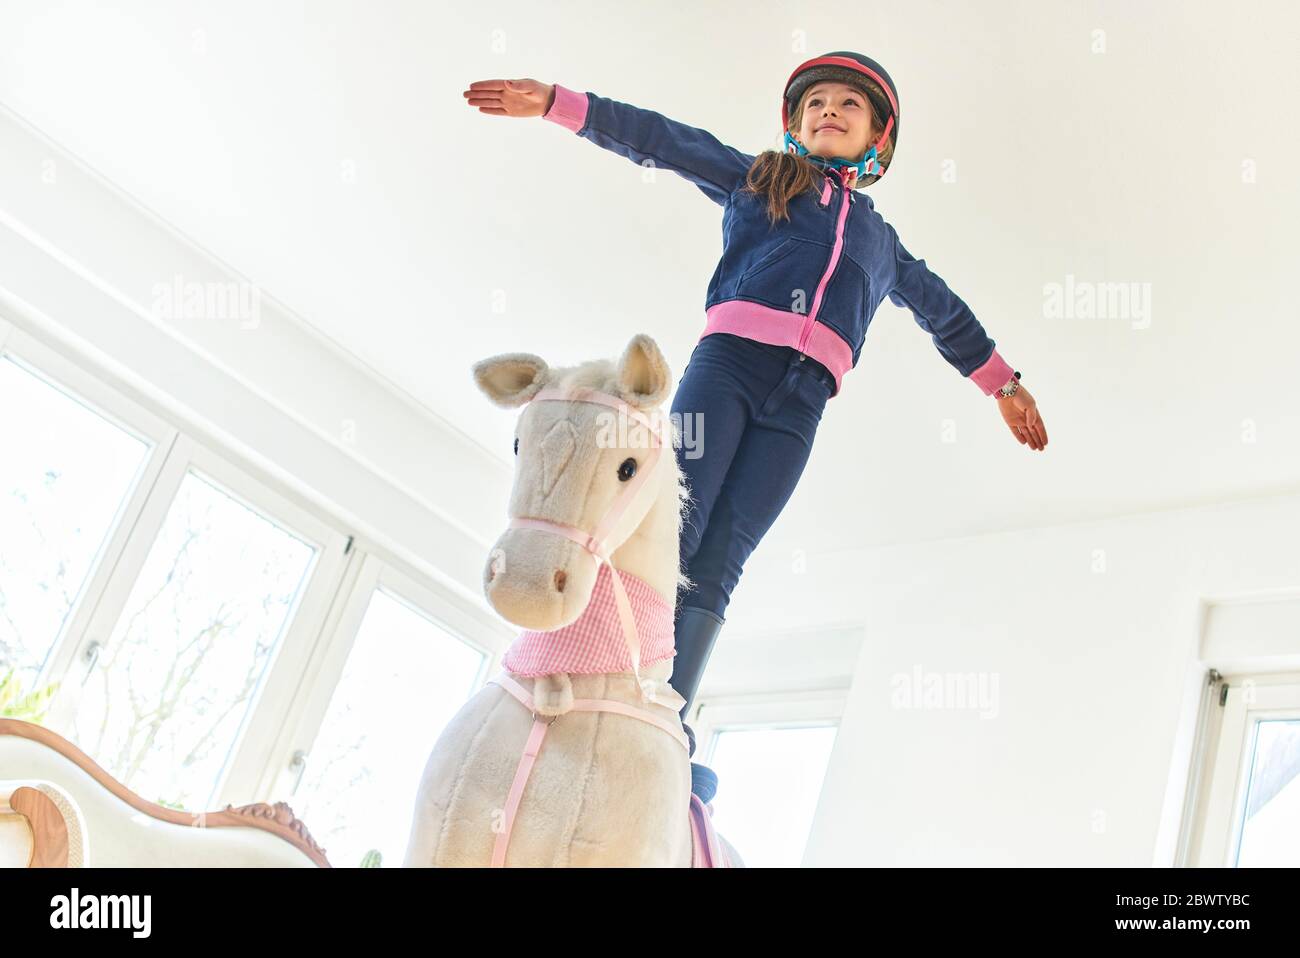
[465,79,754,205]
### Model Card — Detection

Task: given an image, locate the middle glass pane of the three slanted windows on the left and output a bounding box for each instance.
[74,462,316,810]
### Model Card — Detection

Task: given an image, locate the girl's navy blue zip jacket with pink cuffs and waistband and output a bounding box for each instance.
[545,83,1013,395]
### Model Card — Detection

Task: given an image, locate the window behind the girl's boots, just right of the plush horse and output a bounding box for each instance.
[690,692,844,868]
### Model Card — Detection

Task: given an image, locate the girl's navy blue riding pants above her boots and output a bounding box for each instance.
[672,333,835,617]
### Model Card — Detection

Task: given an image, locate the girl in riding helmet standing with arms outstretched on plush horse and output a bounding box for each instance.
[464,51,1048,803]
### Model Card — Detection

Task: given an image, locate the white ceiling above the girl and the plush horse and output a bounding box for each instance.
[0,0,1300,562]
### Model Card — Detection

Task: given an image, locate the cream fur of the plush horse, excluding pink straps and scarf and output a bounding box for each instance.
[404,335,741,867]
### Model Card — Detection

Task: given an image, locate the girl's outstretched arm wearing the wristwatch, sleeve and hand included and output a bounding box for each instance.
[885,224,1048,450]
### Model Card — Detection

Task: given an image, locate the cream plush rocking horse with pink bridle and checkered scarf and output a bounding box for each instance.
[403,335,742,867]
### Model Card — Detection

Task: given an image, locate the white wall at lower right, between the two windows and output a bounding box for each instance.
[805,495,1300,867]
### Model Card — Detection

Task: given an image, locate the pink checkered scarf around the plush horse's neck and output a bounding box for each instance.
[502,563,676,676]
